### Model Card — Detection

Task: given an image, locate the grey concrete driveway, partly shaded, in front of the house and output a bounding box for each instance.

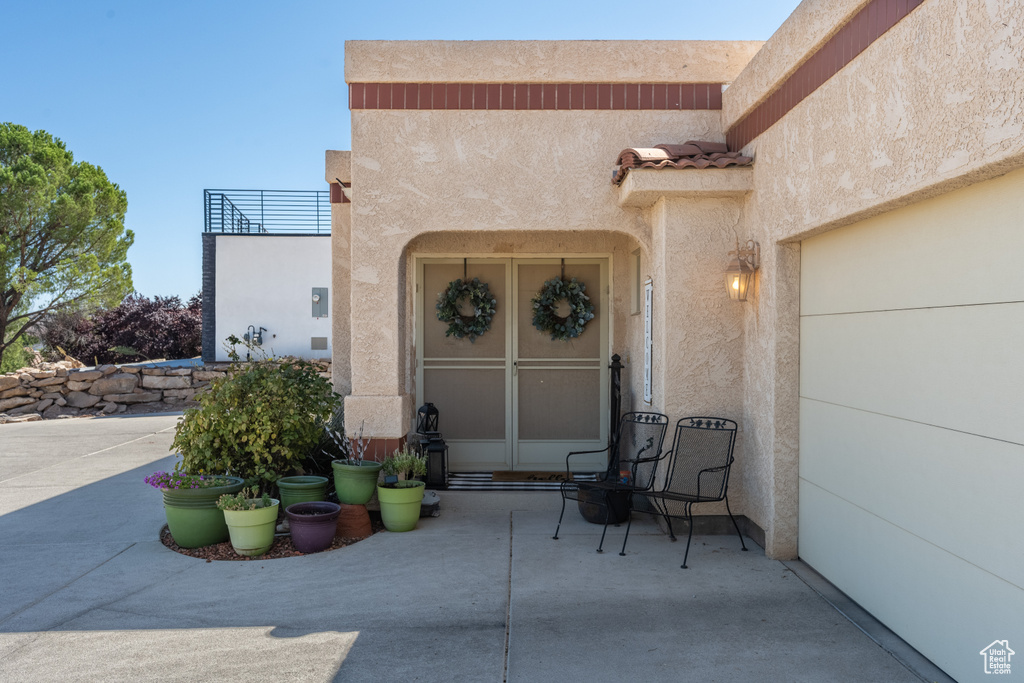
[0,415,942,683]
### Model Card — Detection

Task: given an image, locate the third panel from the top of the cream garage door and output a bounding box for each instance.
[800,399,1024,589]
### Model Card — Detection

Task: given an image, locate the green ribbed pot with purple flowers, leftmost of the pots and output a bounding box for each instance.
[145,472,243,548]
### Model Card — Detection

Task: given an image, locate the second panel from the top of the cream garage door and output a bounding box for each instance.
[800,303,1024,443]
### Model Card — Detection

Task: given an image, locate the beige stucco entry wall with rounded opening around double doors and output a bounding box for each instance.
[337,42,760,532]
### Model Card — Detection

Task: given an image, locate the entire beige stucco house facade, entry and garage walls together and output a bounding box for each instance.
[334,13,1024,557]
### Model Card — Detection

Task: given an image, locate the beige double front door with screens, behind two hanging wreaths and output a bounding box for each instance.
[416,258,609,472]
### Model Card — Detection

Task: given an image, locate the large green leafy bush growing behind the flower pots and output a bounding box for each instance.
[172,338,340,487]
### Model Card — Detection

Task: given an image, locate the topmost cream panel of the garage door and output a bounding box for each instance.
[801,166,1024,315]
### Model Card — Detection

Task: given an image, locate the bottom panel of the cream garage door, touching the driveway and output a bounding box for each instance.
[800,481,1024,680]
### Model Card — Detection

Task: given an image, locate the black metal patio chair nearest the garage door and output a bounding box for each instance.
[618,418,746,569]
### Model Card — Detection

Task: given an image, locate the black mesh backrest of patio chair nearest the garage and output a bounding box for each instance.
[664,418,736,502]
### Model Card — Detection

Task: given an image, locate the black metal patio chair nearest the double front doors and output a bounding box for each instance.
[554,413,669,553]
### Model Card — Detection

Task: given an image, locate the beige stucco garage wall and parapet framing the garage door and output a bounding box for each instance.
[723,0,1024,557]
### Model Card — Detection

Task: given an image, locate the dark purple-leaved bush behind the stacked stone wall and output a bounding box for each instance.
[43,294,203,364]
